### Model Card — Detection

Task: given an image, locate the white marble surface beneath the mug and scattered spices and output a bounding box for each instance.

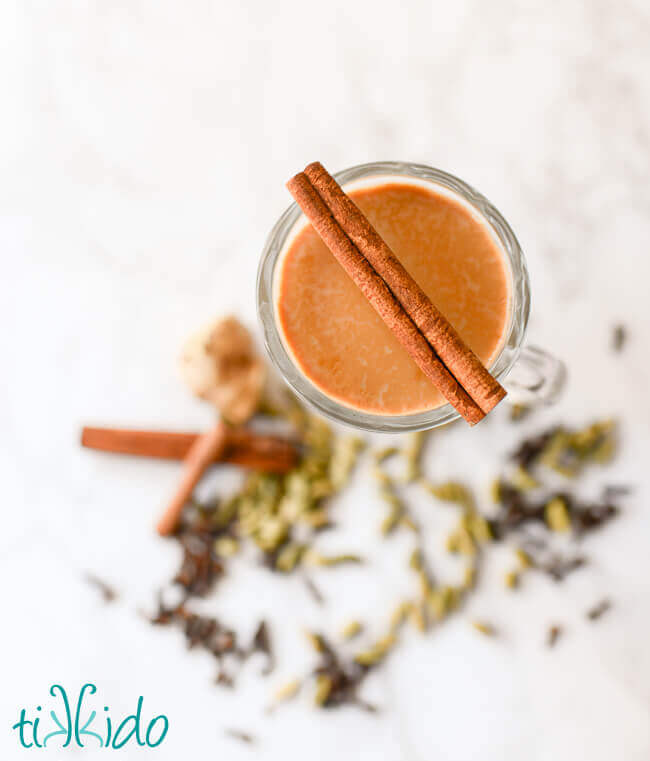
[0,0,650,761]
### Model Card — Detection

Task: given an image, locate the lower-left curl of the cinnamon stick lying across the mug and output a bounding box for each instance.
[287,172,485,425]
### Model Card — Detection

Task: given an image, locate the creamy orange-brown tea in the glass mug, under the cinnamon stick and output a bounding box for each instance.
[274,180,510,415]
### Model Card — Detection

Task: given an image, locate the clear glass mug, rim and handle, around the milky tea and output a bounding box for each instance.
[257,161,564,432]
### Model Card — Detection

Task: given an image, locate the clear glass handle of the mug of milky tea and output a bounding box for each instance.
[503,346,566,404]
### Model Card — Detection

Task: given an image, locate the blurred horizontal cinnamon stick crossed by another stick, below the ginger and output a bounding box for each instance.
[81,426,298,473]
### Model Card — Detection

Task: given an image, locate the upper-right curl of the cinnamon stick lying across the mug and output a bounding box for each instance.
[305,162,506,414]
